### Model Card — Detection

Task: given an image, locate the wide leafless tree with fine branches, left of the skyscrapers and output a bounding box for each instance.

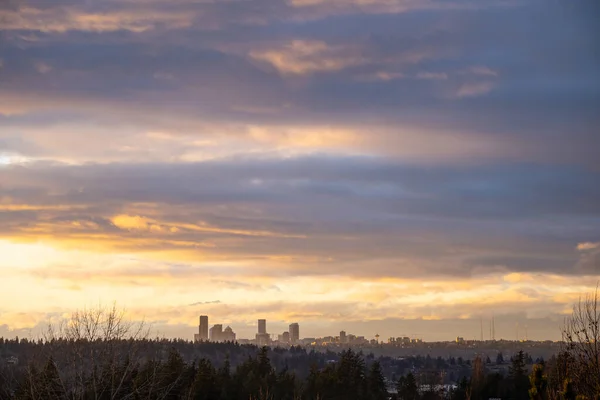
[20,304,165,400]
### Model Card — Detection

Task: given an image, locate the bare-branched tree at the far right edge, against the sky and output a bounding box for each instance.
[562,286,600,399]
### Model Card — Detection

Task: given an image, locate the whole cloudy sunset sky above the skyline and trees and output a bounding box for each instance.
[0,0,600,340]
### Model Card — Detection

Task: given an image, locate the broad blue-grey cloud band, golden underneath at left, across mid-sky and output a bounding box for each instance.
[0,156,600,286]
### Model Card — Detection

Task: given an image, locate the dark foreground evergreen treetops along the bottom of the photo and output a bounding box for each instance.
[0,342,600,400]
